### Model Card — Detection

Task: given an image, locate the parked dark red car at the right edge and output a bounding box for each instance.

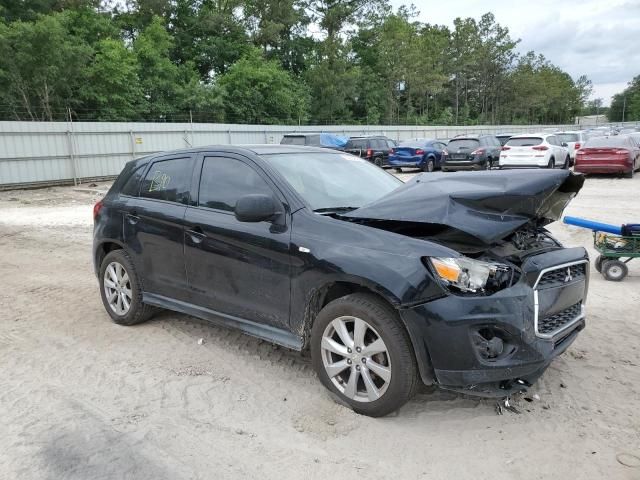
[574,135,640,178]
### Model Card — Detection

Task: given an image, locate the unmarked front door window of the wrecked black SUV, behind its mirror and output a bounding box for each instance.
[198,156,273,212]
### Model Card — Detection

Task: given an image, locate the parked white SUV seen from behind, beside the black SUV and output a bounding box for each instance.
[499,133,571,168]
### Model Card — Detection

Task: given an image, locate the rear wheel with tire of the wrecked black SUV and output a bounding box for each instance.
[99,250,154,325]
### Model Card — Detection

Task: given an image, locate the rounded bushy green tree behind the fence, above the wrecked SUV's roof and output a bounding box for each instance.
[217,49,309,124]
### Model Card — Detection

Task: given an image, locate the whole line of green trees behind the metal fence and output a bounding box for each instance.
[0,0,591,125]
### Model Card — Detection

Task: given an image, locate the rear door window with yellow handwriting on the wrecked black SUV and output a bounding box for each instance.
[140,157,194,205]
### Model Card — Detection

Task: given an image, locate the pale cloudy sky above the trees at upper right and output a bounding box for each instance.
[391,0,640,106]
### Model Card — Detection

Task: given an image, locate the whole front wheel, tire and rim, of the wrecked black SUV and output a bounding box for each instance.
[311,293,418,417]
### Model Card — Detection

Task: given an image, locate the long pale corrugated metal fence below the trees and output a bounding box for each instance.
[0,122,632,189]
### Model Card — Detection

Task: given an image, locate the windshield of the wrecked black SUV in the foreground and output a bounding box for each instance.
[262,152,402,210]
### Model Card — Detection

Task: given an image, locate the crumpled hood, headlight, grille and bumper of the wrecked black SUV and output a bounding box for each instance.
[342,170,589,396]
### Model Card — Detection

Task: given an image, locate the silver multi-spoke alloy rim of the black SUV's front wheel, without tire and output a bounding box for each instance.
[320,316,391,402]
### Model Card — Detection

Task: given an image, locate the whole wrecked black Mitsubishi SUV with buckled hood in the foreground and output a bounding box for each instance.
[93,145,588,416]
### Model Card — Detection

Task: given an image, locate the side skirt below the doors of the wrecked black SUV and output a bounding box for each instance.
[142,292,303,351]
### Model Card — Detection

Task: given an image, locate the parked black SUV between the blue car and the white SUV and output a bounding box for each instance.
[441,135,502,172]
